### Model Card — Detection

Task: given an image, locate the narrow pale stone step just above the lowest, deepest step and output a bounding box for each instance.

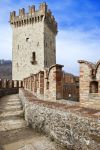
[0,110,24,117]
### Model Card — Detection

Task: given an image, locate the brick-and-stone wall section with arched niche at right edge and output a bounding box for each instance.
[79,60,100,102]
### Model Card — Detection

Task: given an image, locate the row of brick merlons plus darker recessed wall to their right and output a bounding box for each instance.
[24,64,79,101]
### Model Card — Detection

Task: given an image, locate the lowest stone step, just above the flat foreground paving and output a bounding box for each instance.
[0,118,27,131]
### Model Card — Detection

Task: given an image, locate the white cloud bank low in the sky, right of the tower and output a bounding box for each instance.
[57,29,100,74]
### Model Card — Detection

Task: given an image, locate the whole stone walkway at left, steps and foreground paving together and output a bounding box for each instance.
[0,94,63,150]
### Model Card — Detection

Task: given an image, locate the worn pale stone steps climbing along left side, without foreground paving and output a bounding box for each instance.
[0,94,27,131]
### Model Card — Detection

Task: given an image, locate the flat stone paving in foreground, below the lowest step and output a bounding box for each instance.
[0,127,65,150]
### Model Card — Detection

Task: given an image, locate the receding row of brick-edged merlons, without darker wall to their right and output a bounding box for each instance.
[23,64,63,101]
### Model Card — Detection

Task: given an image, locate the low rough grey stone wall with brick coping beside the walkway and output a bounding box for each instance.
[19,90,100,150]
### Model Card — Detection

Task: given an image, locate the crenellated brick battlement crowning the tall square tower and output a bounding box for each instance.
[10,3,57,33]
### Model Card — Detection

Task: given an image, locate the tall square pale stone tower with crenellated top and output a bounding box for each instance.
[10,3,57,80]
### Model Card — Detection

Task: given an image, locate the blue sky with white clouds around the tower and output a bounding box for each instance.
[0,0,100,75]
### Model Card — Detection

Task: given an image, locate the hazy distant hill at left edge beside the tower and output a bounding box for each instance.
[0,59,12,79]
